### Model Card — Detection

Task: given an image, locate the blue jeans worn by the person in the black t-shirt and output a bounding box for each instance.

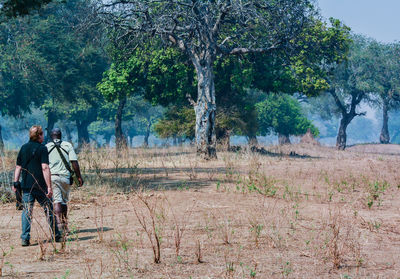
[21,189,61,240]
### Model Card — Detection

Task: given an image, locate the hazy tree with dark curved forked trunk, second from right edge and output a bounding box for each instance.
[328,36,374,150]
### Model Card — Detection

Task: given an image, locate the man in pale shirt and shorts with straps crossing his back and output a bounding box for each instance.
[46,128,83,235]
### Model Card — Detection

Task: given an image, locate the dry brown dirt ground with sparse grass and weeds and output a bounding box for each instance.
[0,145,400,278]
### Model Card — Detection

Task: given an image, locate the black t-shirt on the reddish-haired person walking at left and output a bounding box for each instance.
[17,141,49,193]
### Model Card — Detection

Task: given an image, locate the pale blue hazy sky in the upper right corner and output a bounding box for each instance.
[317,0,400,42]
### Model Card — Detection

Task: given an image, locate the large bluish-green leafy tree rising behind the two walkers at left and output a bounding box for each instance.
[3,0,108,145]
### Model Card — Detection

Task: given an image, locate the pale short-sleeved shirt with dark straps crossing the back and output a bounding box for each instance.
[46,140,78,177]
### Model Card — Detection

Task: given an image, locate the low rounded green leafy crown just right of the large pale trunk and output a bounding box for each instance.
[256,94,319,136]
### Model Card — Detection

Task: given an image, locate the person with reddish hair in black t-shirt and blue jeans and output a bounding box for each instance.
[13,126,62,246]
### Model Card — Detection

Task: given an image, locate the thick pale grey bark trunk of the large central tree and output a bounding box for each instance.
[194,61,217,160]
